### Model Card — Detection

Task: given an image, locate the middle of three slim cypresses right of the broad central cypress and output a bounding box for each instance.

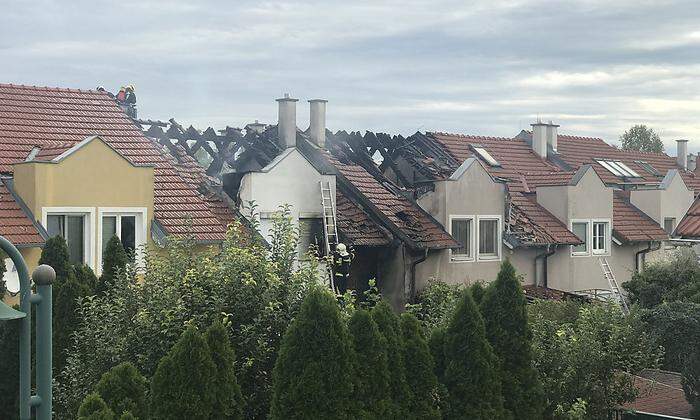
[372,301,409,418]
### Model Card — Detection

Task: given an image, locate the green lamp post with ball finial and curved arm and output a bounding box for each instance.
[0,236,56,420]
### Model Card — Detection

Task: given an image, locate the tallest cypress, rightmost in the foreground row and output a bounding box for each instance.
[481,260,545,420]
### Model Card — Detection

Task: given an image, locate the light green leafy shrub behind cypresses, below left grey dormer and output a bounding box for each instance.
[406,279,464,335]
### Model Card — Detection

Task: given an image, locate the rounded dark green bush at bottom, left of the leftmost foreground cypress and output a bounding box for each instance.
[95,362,148,420]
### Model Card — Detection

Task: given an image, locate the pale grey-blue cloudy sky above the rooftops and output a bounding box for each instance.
[0,0,700,155]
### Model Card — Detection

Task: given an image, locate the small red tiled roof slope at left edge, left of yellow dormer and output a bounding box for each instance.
[0,179,44,247]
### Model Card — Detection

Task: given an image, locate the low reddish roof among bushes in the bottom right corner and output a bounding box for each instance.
[624,369,692,419]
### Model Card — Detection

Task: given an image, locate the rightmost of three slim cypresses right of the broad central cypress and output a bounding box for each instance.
[401,313,441,420]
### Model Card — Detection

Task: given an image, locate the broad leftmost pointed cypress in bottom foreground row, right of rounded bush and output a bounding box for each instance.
[149,326,216,420]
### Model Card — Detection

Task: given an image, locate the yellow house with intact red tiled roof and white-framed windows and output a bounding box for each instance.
[0,84,238,302]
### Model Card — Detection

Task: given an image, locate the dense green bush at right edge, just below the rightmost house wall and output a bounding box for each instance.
[622,248,700,308]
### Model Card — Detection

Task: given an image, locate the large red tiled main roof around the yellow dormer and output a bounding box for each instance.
[0,84,226,242]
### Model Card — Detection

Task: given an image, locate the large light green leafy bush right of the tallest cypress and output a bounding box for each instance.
[528,302,663,419]
